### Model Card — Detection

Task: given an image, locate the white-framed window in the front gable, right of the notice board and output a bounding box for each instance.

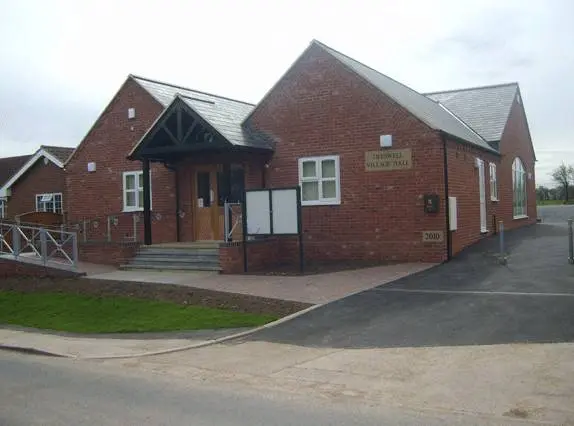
[299,155,341,206]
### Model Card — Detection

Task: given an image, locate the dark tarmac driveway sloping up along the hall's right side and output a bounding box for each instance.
[245,224,574,348]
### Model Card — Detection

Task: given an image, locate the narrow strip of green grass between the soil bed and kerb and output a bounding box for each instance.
[0,291,275,333]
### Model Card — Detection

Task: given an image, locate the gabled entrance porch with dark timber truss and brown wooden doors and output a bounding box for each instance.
[128,94,273,269]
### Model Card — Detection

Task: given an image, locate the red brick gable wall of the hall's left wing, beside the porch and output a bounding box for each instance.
[64,79,176,243]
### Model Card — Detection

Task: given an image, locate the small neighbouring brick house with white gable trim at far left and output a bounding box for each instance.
[0,146,74,219]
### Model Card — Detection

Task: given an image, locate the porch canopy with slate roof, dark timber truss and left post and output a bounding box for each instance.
[128,92,273,245]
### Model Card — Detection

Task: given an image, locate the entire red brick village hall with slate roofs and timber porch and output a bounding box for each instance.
[64,41,536,272]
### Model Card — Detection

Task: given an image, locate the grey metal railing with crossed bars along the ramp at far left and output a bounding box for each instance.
[0,222,78,269]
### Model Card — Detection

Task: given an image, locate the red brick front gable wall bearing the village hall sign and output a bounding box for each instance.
[251,46,446,261]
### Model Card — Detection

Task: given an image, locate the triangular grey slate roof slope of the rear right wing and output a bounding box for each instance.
[426,83,518,142]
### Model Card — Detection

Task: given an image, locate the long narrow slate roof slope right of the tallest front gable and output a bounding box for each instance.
[312,40,496,152]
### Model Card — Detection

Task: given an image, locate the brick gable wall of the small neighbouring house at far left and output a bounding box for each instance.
[7,159,67,218]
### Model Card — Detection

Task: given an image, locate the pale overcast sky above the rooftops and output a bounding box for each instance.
[0,0,574,184]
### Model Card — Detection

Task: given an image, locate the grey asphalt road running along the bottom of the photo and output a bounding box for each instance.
[0,354,524,426]
